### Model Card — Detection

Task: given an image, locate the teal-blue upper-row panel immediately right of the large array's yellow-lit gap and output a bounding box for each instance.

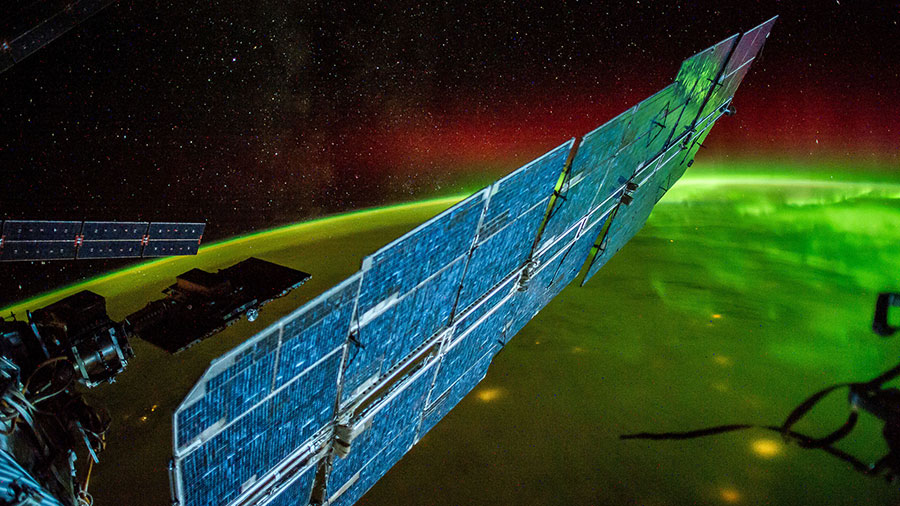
[538,108,634,249]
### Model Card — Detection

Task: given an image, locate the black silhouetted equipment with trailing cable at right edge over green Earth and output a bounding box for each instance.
[619,293,900,482]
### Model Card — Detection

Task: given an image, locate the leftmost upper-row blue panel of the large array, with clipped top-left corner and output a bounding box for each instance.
[175,274,360,506]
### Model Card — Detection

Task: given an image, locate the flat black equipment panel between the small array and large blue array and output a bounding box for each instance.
[126,257,310,353]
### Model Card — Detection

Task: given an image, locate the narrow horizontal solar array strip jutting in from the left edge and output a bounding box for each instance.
[0,220,206,262]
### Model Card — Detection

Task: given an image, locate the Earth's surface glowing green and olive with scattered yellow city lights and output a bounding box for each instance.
[2,159,900,506]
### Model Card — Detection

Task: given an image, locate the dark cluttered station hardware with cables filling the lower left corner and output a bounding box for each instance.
[0,291,134,506]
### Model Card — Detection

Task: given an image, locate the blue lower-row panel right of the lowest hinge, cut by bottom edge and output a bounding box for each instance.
[327,361,437,506]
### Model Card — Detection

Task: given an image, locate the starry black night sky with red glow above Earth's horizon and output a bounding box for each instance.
[0,0,900,302]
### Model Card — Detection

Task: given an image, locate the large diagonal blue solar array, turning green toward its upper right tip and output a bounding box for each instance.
[172,20,772,506]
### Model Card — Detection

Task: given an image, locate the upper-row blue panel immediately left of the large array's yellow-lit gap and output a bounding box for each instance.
[457,141,574,310]
